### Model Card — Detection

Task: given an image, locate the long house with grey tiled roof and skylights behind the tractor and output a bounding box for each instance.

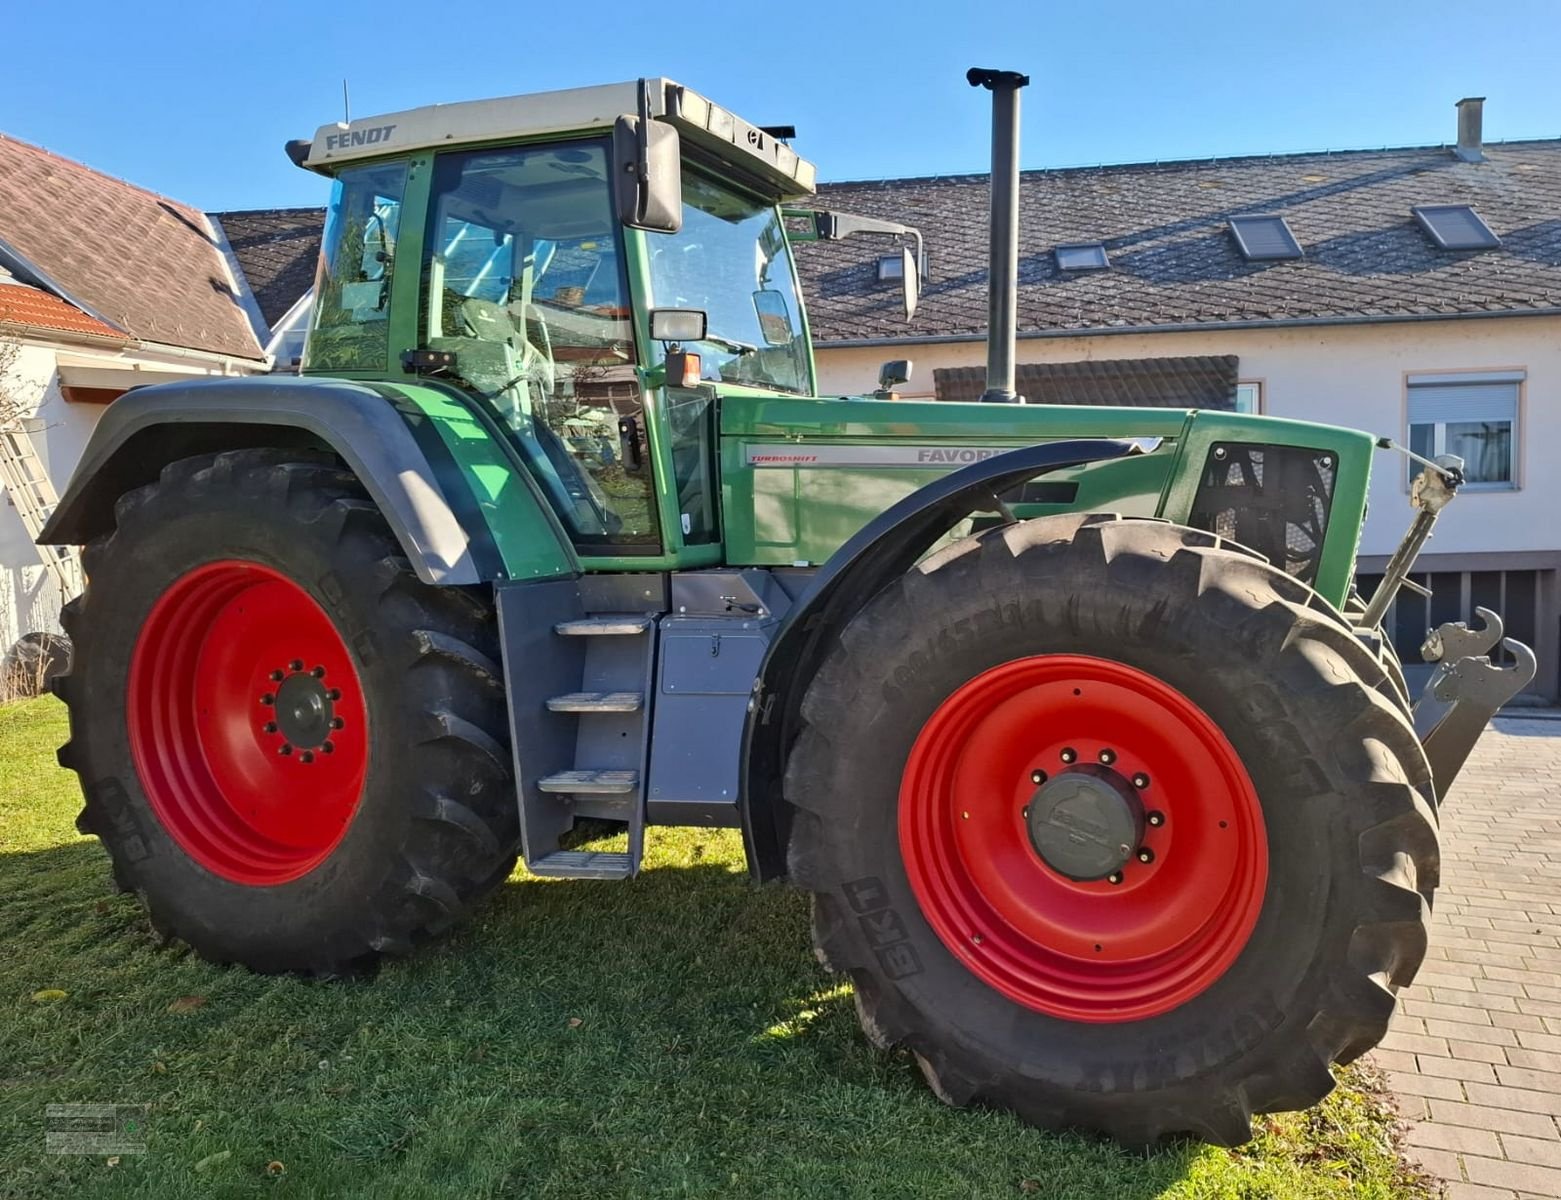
[220,100,1561,696]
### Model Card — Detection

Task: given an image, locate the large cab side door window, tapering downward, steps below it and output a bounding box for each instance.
[420,142,660,552]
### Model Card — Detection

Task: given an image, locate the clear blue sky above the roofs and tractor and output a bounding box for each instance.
[0,0,1561,209]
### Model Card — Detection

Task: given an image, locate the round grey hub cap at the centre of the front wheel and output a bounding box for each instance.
[1026,763,1146,880]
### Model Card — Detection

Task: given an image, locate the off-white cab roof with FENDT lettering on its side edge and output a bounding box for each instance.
[289,76,816,200]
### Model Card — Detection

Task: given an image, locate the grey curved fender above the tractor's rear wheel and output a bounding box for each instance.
[37,376,536,584]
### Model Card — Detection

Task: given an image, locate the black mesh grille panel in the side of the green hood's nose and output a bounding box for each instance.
[1188,442,1338,584]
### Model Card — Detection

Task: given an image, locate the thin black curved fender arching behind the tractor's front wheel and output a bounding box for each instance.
[740,438,1146,882]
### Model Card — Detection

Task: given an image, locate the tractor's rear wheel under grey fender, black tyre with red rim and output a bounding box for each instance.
[56,449,518,975]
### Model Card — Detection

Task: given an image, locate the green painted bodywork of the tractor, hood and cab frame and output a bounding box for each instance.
[303,128,1374,604]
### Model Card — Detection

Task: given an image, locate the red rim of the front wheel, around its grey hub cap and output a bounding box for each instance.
[899,654,1268,1022]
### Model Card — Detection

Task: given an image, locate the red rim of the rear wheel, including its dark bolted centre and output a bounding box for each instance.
[126,560,368,885]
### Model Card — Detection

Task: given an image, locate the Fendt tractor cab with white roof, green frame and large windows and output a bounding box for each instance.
[290,78,913,565]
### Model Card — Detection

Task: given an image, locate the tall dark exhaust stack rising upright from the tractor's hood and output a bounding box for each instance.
[965,67,1030,404]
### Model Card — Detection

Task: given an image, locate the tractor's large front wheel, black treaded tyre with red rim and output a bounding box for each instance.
[785,515,1438,1145]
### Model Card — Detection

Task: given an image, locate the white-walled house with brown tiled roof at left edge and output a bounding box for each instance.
[0,134,270,674]
